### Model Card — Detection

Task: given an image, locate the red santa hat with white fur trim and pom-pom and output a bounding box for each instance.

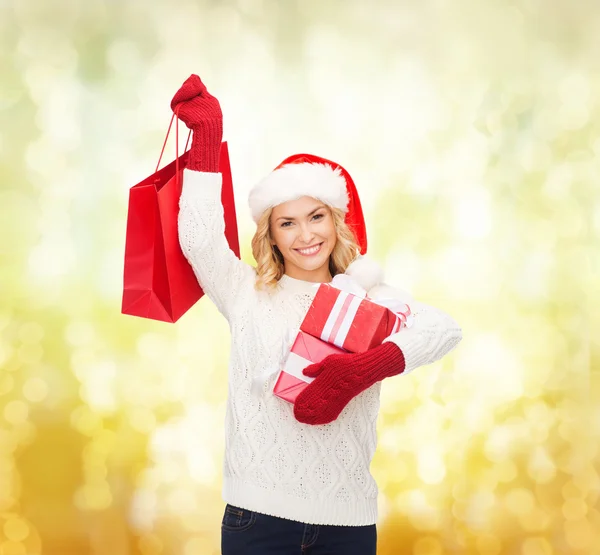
[249,154,383,291]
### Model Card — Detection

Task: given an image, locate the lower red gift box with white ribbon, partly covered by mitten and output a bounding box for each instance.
[273,331,346,403]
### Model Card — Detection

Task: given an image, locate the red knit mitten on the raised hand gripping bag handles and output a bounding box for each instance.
[171,75,223,173]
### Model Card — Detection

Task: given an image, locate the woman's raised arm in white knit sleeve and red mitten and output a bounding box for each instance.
[171,75,255,318]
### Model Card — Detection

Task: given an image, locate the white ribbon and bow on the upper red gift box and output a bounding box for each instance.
[321,274,413,347]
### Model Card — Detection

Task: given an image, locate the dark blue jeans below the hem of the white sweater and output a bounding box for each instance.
[221,505,377,555]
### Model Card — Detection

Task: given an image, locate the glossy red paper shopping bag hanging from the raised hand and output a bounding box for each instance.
[121,115,240,322]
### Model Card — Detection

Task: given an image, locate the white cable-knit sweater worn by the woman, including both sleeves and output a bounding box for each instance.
[179,169,461,526]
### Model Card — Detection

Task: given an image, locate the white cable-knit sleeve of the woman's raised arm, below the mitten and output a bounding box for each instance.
[178,169,256,318]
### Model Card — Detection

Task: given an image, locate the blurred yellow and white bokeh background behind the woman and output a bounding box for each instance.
[0,0,600,555]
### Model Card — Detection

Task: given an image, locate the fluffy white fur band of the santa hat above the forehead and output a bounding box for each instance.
[248,163,348,222]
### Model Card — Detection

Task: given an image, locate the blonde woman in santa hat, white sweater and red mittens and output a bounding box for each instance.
[171,75,461,555]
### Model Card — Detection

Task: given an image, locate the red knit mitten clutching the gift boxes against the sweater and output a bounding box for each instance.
[294,342,404,424]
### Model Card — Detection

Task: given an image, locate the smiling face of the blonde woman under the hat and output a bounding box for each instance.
[270,197,337,282]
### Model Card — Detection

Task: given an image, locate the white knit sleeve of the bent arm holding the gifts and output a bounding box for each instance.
[372,284,462,374]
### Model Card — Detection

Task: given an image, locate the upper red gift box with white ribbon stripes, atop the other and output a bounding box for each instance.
[300,283,410,353]
